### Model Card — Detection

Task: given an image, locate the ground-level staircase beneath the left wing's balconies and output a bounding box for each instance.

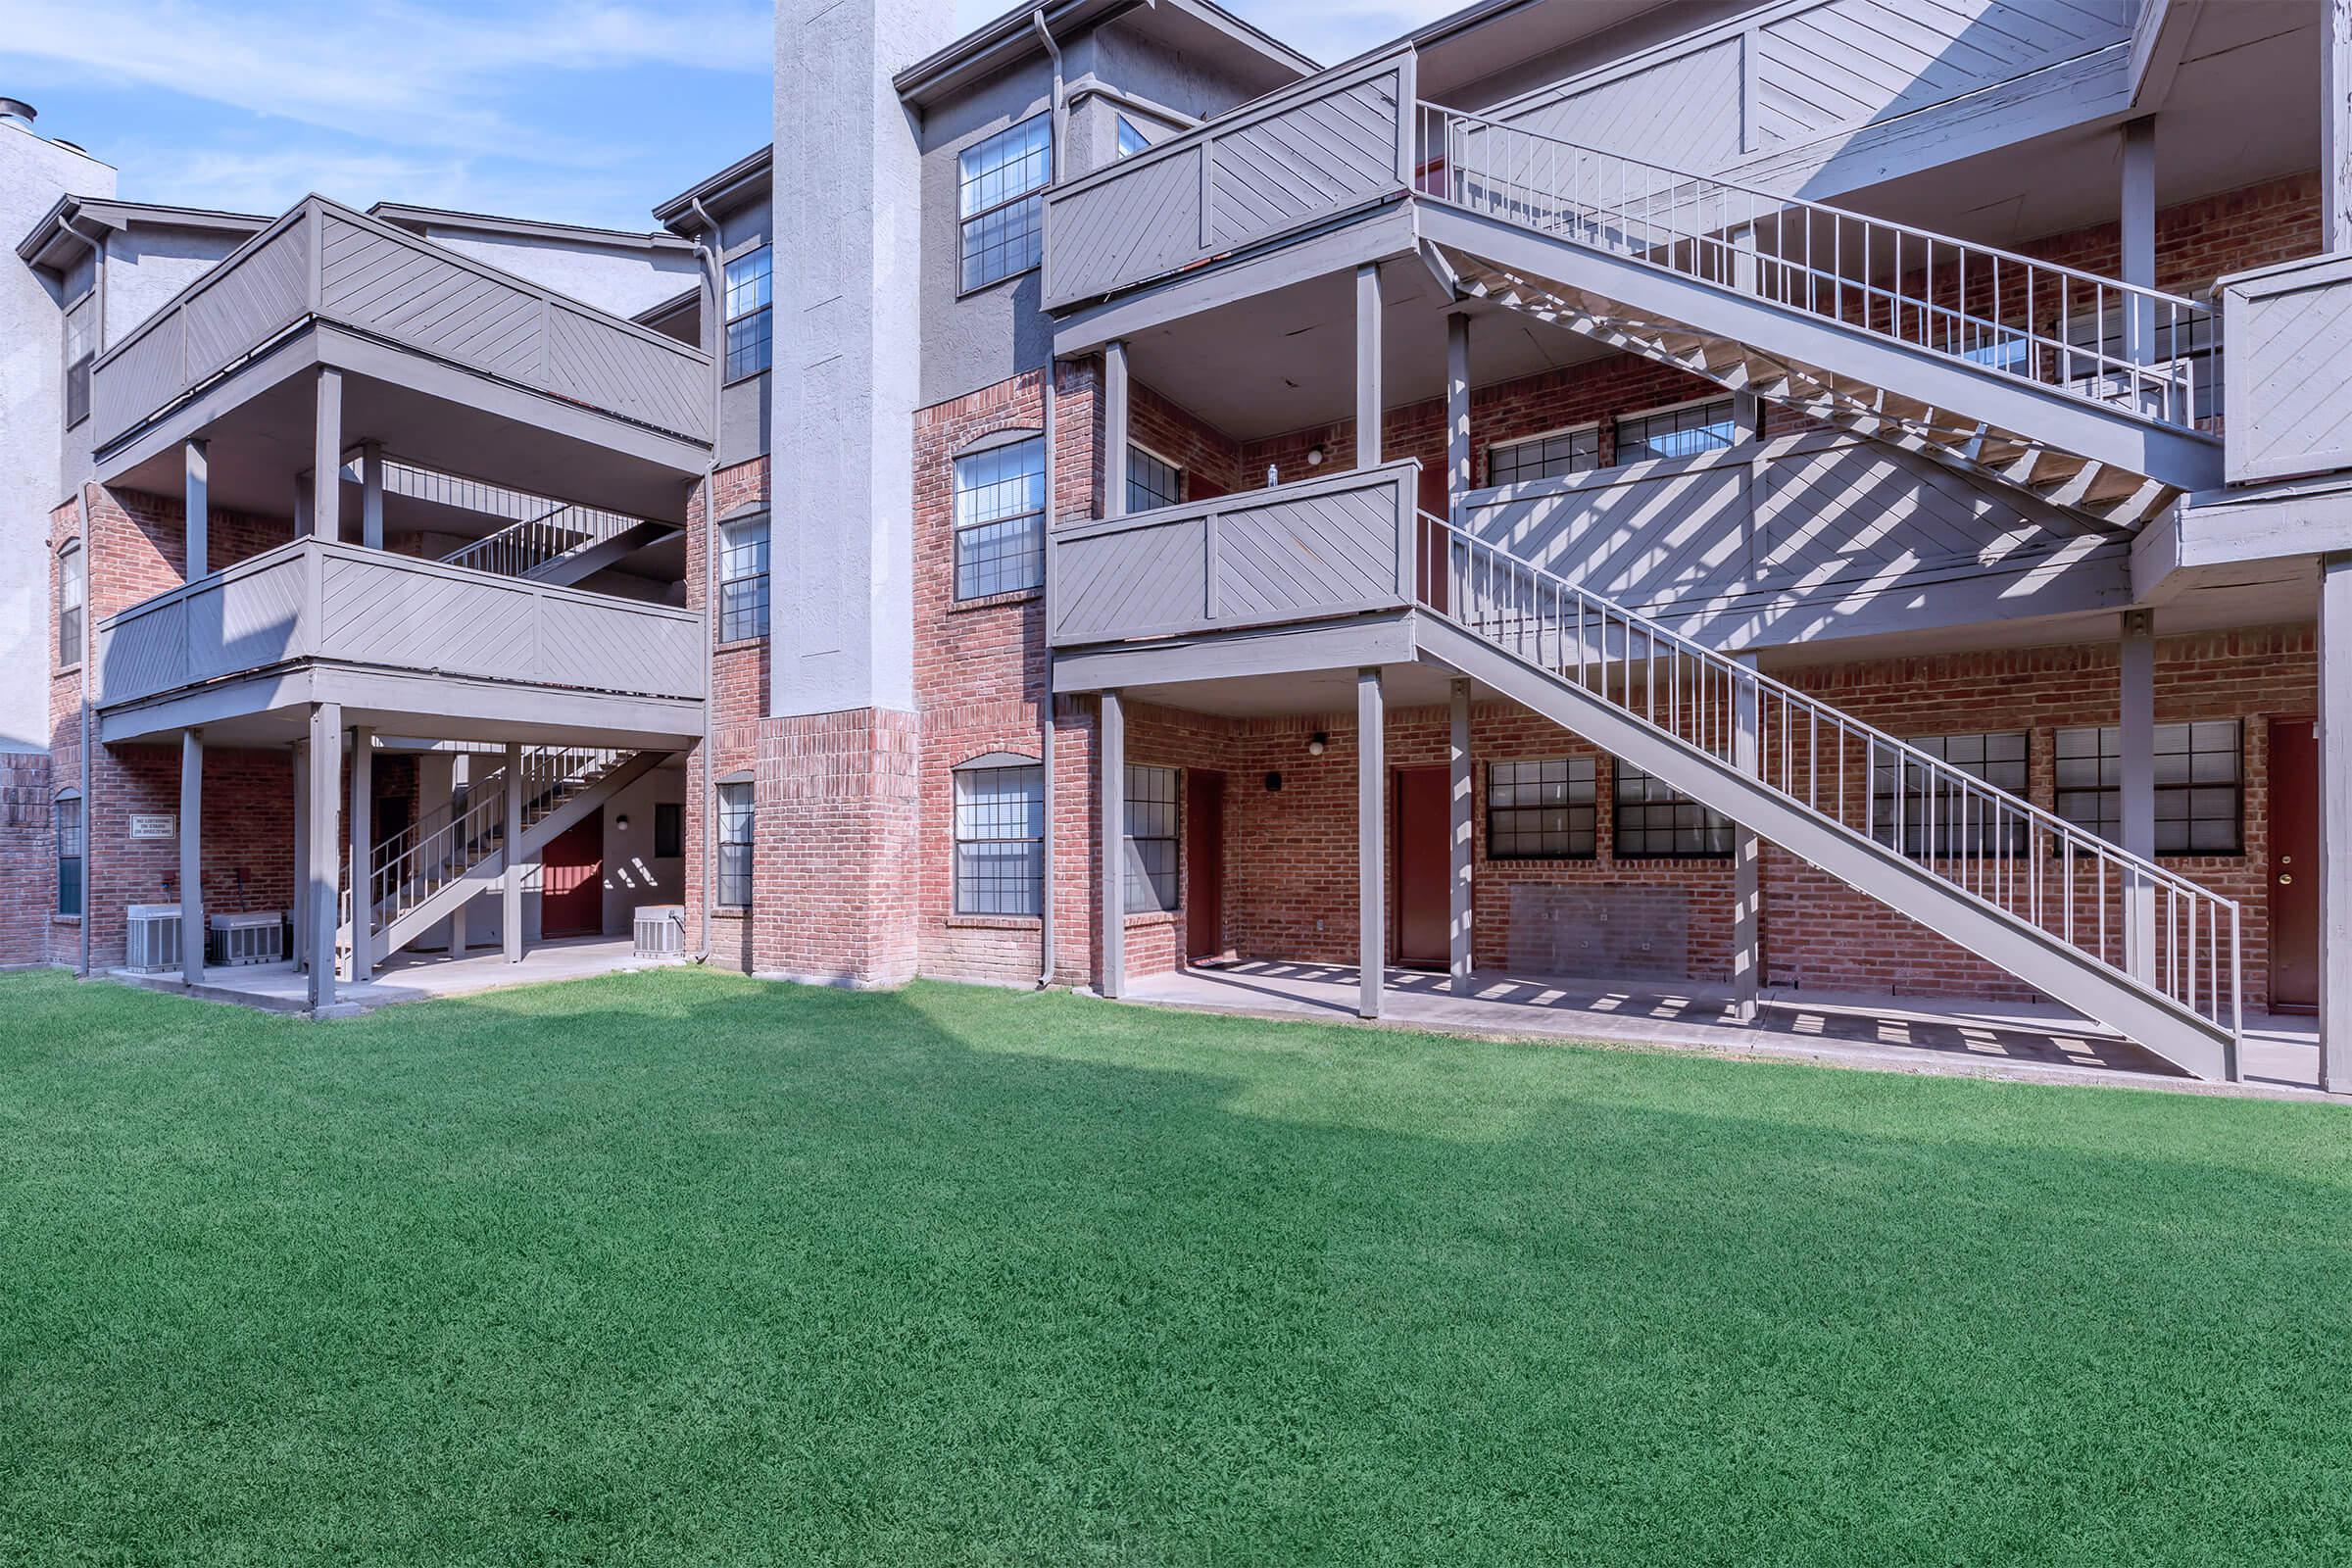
[336,745,665,973]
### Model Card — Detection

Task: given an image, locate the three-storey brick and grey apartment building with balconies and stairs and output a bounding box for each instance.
[10,0,2352,1089]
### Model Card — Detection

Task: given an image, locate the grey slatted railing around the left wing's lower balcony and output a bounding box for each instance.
[96,538,704,708]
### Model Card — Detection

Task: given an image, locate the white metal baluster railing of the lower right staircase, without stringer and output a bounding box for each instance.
[1418,513,2244,1062]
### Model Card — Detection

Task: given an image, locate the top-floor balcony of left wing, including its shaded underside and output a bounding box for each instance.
[92,195,712,522]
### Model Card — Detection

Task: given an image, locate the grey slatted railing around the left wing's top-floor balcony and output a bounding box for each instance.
[92,195,710,447]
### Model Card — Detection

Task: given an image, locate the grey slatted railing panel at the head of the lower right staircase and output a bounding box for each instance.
[1047,459,1421,647]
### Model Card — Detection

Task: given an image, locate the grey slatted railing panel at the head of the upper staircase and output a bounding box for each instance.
[1042,49,1413,311]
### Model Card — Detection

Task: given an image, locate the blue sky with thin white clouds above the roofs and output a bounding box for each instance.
[0,0,1453,228]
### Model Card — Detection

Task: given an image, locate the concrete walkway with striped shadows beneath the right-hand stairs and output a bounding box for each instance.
[1127,961,2333,1098]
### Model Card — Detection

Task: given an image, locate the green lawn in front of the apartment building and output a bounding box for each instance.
[0,971,2352,1568]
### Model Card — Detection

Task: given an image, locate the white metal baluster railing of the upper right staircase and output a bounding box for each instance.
[1413,104,2221,428]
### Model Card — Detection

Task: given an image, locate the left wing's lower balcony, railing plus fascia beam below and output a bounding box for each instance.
[96,538,704,743]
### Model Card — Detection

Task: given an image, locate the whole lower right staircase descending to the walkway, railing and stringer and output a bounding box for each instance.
[1418,514,2244,1079]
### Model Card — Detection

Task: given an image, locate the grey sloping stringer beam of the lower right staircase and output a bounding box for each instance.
[1413,612,2234,1079]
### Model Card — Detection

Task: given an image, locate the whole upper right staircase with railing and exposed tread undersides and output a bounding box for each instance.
[1416,104,2221,531]
